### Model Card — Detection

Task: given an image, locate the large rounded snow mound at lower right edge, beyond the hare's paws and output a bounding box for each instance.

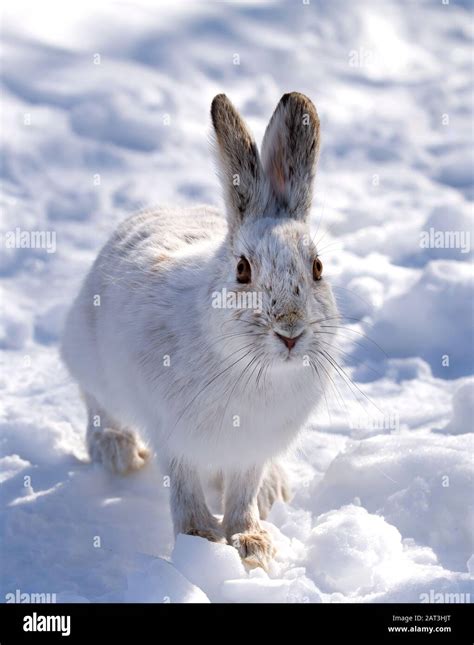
[311,434,474,571]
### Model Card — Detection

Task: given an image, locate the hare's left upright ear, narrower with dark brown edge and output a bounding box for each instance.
[211,94,268,230]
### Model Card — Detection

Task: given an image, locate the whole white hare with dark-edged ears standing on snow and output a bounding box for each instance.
[62,93,337,567]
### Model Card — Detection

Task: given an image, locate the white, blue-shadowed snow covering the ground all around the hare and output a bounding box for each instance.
[0,0,474,602]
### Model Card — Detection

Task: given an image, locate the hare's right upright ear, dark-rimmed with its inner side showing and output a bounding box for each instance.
[262,92,319,219]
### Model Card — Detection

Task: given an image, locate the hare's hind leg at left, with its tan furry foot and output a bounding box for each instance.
[84,394,150,475]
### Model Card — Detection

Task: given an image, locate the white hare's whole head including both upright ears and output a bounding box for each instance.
[211,92,337,370]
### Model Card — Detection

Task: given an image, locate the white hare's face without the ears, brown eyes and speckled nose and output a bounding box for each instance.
[229,218,337,364]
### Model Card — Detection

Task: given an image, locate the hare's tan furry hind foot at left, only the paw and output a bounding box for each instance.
[89,428,150,475]
